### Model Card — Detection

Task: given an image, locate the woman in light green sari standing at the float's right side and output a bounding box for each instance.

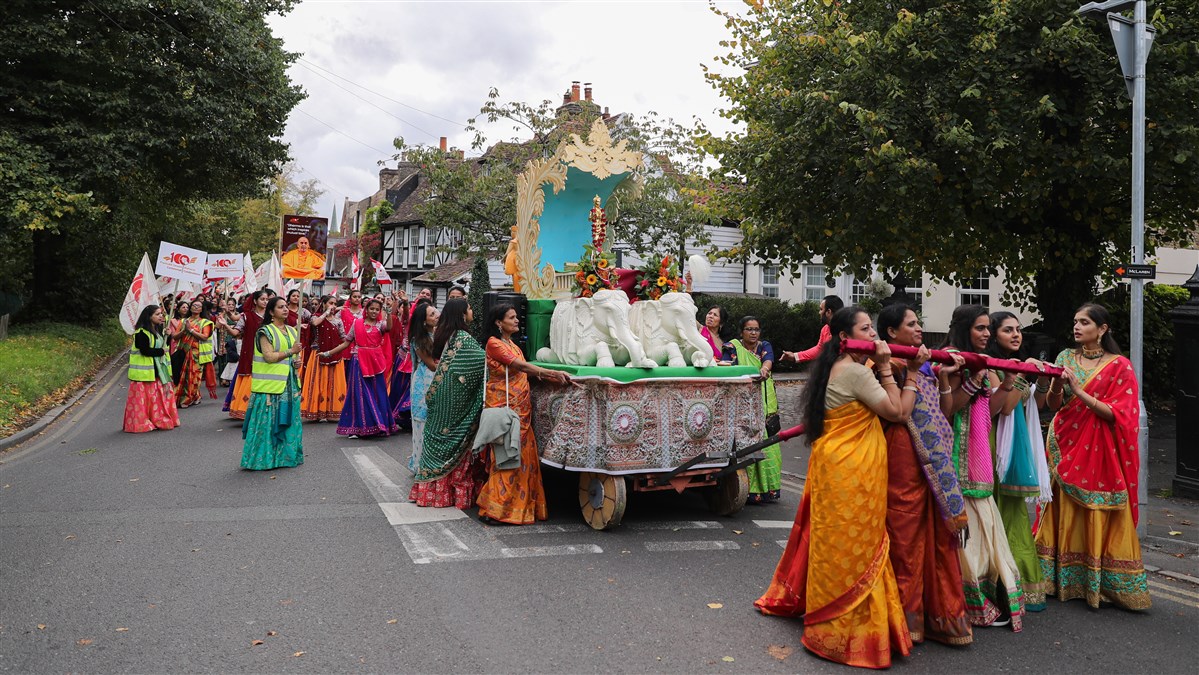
[721,317,783,504]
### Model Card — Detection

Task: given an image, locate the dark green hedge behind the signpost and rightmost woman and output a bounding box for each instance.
[1095,284,1191,409]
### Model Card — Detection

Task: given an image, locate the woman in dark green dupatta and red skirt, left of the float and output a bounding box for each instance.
[408,297,487,510]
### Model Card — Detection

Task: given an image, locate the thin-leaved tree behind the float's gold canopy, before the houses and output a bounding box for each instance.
[396,89,713,263]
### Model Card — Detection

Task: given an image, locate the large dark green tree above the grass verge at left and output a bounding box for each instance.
[0,0,303,320]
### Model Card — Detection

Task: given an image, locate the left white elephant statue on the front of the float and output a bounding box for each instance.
[537,290,657,368]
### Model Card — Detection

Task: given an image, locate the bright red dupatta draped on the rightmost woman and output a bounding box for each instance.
[1048,349,1140,524]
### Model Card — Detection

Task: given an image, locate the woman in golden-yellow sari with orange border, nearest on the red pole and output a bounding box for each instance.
[754,307,928,668]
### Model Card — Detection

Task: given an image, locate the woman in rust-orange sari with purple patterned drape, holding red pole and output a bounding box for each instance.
[879,305,974,645]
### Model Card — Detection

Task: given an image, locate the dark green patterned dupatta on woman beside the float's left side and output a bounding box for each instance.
[414,331,487,483]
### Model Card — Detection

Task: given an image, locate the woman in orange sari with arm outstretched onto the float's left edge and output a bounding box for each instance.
[477,305,571,525]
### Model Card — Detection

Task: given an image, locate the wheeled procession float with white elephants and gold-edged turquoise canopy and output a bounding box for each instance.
[505,120,777,530]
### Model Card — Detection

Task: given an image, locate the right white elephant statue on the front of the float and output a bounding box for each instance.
[628,293,716,368]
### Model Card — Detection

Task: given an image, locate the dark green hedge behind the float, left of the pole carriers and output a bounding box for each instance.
[692,293,820,370]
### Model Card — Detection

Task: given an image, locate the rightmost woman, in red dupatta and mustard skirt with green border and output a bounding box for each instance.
[1036,305,1151,609]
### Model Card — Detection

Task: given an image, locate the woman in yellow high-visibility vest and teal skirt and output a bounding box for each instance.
[241,297,303,471]
